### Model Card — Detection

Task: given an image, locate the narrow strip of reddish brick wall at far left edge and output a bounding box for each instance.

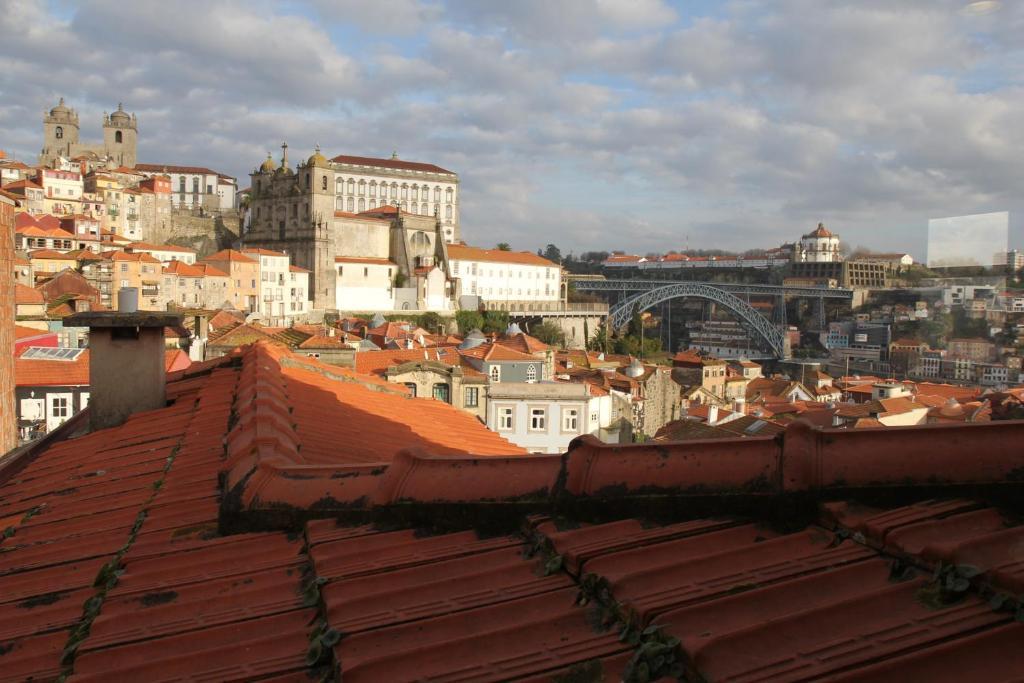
[0,196,17,455]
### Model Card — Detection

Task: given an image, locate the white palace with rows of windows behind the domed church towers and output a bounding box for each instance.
[331,155,461,243]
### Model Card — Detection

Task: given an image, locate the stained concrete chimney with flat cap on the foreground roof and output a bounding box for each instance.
[63,305,182,431]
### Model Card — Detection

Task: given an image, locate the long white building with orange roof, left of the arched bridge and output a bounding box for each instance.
[447,245,562,310]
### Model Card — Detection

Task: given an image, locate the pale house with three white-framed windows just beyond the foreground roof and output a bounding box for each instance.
[486,382,611,454]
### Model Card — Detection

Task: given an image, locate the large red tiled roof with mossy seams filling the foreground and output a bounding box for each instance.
[6,344,1024,683]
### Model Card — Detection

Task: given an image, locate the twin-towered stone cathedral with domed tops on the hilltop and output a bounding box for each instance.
[39,97,138,168]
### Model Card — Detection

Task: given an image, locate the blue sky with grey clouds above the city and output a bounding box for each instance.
[0,0,1024,257]
